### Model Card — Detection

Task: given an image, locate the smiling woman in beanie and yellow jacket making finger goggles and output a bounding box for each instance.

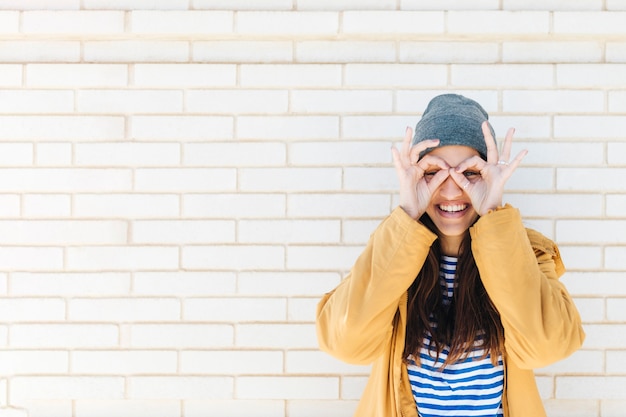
[317,94,584,417]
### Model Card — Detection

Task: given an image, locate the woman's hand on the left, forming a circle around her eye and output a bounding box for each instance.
[391,127,450,220]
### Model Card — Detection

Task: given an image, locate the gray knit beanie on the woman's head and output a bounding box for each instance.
[412,94,496,160]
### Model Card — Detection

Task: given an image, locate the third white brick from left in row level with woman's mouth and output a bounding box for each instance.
[73,193,180,219]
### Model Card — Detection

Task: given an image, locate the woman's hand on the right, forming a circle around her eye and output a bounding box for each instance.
[450,122,528,216]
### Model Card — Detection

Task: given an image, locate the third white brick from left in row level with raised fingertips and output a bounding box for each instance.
[237,115,339,140]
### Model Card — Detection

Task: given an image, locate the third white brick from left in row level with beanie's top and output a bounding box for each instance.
[185,90,289,114]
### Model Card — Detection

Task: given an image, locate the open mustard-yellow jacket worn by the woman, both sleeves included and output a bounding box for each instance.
[317,205,585,417]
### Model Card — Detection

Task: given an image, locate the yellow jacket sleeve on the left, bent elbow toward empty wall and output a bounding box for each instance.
[316,207,436,364]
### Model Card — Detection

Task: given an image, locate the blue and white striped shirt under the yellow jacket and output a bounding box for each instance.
[407,256,504,417]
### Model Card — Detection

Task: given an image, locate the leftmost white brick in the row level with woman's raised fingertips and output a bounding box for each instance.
[0,115,124,141]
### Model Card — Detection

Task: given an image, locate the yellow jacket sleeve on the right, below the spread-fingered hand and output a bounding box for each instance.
[470,205,585,369]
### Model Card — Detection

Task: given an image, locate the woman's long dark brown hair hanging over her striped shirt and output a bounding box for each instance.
[404,214,504,368]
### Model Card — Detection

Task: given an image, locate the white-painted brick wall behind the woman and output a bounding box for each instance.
[0,0,626,417]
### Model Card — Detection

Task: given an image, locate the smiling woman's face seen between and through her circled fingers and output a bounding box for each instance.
[425,145,480,245]
